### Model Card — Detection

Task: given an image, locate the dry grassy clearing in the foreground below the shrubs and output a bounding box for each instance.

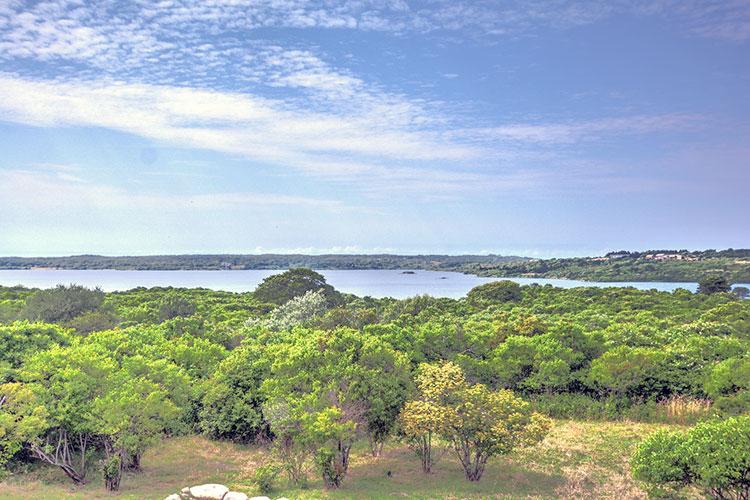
[0,421,680,500]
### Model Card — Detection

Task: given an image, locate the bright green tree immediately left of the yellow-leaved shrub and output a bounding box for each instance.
[262,329,408,488]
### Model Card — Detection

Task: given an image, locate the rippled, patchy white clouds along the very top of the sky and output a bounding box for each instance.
[0,0,750,91]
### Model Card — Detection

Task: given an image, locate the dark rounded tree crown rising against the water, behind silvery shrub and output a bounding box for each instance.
[253,267,343,307]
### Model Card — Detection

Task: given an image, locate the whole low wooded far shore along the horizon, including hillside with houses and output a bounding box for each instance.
[0,252,750,283]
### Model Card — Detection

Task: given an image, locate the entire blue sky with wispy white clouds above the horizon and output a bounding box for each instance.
[0,0,750,257]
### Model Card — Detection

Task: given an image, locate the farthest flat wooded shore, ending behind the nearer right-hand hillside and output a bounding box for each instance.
[0,254,529,270]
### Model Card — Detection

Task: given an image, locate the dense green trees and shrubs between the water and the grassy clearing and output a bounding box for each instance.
[0,271,750,489]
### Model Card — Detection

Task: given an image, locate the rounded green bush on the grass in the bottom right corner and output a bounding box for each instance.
[631,415,750,500]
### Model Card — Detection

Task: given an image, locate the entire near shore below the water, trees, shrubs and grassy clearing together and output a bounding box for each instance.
[0,272,750,500]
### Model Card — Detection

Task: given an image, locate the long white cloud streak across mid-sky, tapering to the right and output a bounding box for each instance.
[0,74,698,201]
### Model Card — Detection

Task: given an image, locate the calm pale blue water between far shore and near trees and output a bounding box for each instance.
[0,269,750,299]
